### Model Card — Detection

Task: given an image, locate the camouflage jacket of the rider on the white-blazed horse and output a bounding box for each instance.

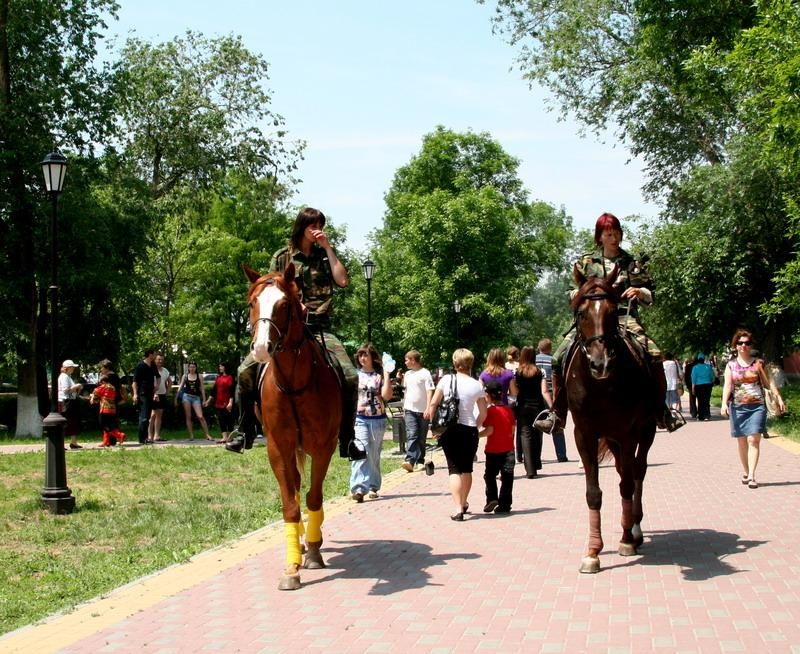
[269,245,335,329]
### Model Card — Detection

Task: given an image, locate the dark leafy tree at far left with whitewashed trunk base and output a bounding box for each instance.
[0,0,117,435]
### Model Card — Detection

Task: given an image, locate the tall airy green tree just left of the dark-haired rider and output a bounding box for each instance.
[115,32,304,372]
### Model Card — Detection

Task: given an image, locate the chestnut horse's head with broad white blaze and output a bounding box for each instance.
[242,263,304,363]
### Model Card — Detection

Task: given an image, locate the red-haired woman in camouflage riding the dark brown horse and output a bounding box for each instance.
[536,213,685,433]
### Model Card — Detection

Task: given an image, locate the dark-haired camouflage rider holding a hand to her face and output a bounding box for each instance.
[225,207,358,457]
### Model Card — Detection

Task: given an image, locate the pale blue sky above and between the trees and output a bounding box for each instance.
[109,0,657,251]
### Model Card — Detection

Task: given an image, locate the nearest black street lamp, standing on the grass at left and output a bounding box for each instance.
[42,152,75,514]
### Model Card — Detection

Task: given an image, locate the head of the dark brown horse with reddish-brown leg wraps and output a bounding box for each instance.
[572,266,620,379]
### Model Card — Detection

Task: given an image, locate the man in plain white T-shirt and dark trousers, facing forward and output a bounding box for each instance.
[402,350,436,472]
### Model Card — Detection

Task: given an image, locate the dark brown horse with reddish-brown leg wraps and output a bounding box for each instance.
[564,266,658,573]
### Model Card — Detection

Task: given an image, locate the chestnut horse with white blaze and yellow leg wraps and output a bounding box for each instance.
[244,264,342,590]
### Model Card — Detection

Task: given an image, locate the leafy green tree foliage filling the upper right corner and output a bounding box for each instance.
[484,0,800,356]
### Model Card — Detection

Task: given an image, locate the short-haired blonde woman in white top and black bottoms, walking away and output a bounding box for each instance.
[425,348,486,521]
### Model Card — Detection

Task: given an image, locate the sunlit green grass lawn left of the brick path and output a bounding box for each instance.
[0,431,401,633]
